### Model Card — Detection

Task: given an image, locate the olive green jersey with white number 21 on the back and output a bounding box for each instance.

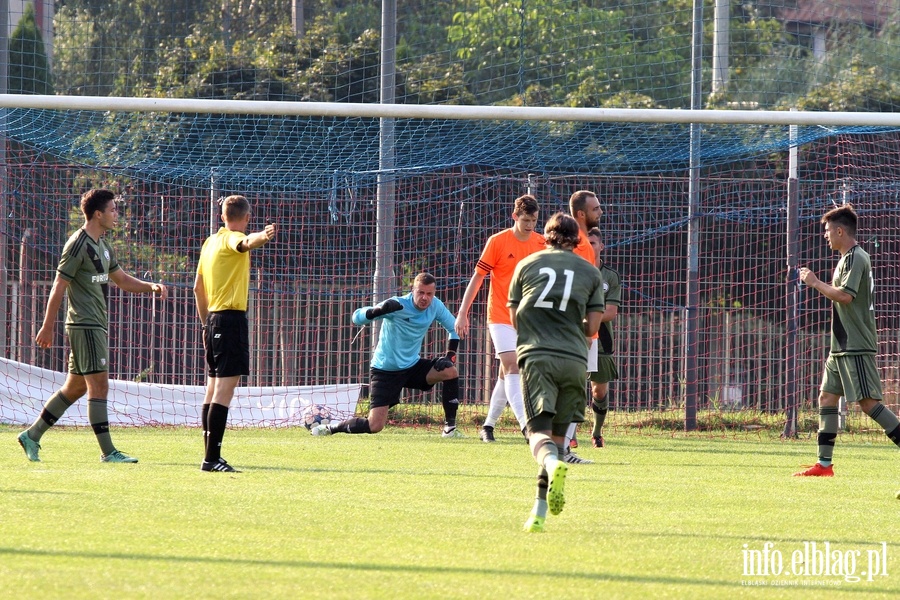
[509,249,604,364]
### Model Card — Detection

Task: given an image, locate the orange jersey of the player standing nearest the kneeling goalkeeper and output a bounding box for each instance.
[475,229,544,325]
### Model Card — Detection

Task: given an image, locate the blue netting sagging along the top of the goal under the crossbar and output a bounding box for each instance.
[6,109,890,190]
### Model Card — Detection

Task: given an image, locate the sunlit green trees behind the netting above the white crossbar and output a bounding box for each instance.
[54,0,900,110]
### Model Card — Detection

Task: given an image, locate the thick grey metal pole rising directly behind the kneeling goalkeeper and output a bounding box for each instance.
[372,0,397,343]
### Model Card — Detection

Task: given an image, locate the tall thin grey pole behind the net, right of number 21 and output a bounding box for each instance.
[683,0,703,431]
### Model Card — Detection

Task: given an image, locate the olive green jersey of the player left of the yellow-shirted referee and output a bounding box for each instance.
[56,229,119,329]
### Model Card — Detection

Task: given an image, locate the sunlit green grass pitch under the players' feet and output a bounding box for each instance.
[0,427,900,600]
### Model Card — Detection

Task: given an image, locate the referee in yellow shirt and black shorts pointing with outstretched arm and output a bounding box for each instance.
[194,195,276,473]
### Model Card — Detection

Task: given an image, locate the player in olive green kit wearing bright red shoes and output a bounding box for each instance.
[794,204,900,477]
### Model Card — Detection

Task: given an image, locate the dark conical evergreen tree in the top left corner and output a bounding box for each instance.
[7,3,53,94]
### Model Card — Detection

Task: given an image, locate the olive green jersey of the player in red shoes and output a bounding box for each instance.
[831,246,878,356]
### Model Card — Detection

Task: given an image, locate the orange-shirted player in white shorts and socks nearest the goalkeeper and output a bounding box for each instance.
[456,194,545,442]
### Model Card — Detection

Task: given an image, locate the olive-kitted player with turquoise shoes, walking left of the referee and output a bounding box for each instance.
[18,189,169,463]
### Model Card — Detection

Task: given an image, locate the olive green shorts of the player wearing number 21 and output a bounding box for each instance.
[519,354,586,436]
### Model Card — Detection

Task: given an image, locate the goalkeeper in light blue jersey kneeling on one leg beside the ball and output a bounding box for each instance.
[312,273,462,438]
